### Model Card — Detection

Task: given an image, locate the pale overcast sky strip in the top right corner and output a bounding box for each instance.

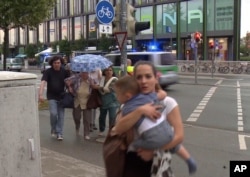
[240,0,250,37]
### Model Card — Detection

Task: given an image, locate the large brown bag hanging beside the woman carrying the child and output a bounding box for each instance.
[103,126,133,177]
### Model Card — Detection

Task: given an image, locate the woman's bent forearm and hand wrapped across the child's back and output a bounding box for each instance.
[113,103,161,134]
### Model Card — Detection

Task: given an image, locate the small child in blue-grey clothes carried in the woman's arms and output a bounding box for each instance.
[115,76,197,174]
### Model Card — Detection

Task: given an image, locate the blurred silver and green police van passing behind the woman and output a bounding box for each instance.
[105,51,179,88]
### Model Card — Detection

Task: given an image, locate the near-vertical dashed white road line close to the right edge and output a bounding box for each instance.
[237,81,244,132]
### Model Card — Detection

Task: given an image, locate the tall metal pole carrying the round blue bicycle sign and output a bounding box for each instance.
[120,0,127,76]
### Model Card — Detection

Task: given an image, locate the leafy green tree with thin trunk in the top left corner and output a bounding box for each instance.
[0,0,56,70]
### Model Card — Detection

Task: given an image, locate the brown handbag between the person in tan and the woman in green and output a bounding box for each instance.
[86,89,102,109]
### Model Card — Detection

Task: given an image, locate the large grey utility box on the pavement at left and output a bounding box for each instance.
[0,71,42,177]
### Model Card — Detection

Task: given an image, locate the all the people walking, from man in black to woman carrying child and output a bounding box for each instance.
[39,56,197,177]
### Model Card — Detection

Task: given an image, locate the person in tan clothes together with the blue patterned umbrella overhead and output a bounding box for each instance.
[68,54,115,139]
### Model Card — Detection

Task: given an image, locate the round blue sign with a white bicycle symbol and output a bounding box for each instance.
[95,0,115,24]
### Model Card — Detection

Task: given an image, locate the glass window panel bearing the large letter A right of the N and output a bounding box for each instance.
[187,0,203,32]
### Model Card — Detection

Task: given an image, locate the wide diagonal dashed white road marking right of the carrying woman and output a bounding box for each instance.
[187,87,217,122]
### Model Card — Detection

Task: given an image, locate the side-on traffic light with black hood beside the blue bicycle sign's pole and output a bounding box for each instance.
[127,3,150,37]
